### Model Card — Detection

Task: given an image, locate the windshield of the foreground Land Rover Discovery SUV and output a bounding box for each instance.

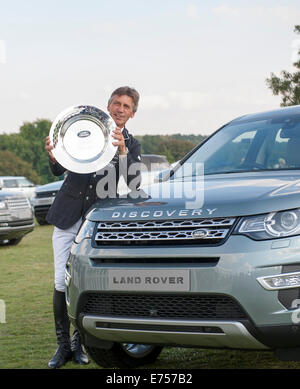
[174,115,300,178]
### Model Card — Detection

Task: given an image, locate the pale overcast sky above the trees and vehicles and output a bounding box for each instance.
[0,0,300,135]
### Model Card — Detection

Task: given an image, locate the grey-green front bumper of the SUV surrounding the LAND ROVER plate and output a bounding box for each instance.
[67,236,300,349]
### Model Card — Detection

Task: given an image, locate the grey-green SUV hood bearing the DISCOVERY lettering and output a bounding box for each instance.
[87,171,300,221]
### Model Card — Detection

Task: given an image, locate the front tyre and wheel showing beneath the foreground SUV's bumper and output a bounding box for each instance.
[85,343,162,368]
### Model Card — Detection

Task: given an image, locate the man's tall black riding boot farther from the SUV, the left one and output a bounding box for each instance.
[48,289,72,369]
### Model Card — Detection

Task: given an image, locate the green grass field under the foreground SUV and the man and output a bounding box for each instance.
[0,225,300,369]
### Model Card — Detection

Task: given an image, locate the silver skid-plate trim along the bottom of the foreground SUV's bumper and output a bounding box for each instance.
[82,316,267,349]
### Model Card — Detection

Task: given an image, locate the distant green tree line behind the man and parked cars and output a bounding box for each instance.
[0,119,205,184]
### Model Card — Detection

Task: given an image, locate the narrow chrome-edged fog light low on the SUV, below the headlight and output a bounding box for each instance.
[257,272,300,290]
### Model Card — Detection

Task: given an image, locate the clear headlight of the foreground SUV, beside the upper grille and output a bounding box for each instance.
[234,208,300,240]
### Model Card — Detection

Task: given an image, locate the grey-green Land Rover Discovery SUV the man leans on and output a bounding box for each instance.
[66,106,300,367]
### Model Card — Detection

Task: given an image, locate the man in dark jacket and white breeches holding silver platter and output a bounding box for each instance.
[45,87,141,369]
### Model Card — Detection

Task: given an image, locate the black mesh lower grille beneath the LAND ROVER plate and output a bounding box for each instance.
[79,292,247,320]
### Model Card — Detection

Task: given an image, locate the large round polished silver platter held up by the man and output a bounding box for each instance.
[49,105,117,173]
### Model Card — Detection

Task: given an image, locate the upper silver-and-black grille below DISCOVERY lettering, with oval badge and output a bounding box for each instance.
[94,218,235,246]
